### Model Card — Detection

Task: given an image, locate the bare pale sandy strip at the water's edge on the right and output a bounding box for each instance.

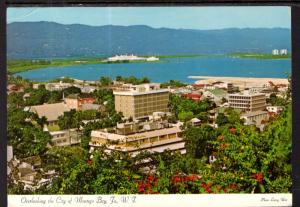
[189,76,288,89]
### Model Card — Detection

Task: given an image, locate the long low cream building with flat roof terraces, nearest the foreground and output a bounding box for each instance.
[89,122,186,156]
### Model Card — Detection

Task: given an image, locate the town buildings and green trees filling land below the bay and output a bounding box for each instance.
[7,68,291,194]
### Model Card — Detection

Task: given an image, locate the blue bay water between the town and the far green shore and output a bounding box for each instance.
[16,57,291,83]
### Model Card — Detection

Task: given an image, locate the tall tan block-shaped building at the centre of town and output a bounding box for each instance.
[113,84,169,119]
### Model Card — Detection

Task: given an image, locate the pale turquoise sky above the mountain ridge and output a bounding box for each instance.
[7,6,291,30]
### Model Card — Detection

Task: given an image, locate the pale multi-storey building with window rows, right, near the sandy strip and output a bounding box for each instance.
[228,91,266,112]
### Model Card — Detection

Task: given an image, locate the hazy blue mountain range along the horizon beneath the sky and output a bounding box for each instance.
[7,22,291,59]
